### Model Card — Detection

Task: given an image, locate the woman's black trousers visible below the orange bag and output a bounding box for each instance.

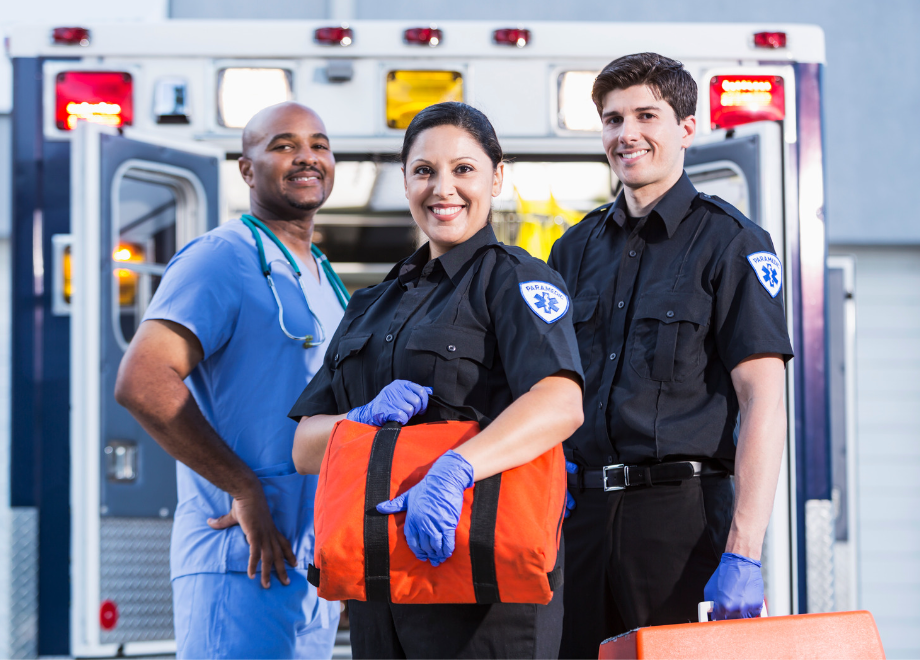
[348,547,564,658]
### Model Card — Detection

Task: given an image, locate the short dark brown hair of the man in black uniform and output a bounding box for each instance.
[591,53,697,121]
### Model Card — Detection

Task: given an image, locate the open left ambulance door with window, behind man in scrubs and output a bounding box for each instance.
[68,122,223,656]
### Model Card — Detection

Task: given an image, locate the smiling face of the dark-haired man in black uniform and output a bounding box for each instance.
[601,85,696,197]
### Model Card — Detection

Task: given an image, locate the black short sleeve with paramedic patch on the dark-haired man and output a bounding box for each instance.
[714,229,793,371]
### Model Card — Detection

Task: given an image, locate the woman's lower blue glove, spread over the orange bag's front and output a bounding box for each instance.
[377,449,473,566]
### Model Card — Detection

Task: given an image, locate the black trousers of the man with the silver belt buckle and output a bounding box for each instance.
[559,476,734,658]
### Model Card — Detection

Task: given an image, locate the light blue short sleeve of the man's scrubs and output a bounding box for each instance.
[144,234,243,359]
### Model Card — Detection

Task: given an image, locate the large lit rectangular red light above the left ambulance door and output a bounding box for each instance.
[54,71,134,131]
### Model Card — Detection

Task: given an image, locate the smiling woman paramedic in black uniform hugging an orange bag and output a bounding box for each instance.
[290,103,582,658]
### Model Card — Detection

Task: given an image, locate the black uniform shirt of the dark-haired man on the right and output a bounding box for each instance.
[549,174,792,467]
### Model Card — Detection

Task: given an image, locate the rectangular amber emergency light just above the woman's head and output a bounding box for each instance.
[386,71,463,128]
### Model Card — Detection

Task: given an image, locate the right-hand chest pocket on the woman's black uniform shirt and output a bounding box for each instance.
[406,324,496,404]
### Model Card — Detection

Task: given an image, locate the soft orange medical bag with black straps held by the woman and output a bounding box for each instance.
[308,397,566,604]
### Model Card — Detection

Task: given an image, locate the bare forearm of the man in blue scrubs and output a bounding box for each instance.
[117,364,261,497]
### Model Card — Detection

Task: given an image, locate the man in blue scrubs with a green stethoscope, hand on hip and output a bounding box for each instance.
[115,103,344,658]
